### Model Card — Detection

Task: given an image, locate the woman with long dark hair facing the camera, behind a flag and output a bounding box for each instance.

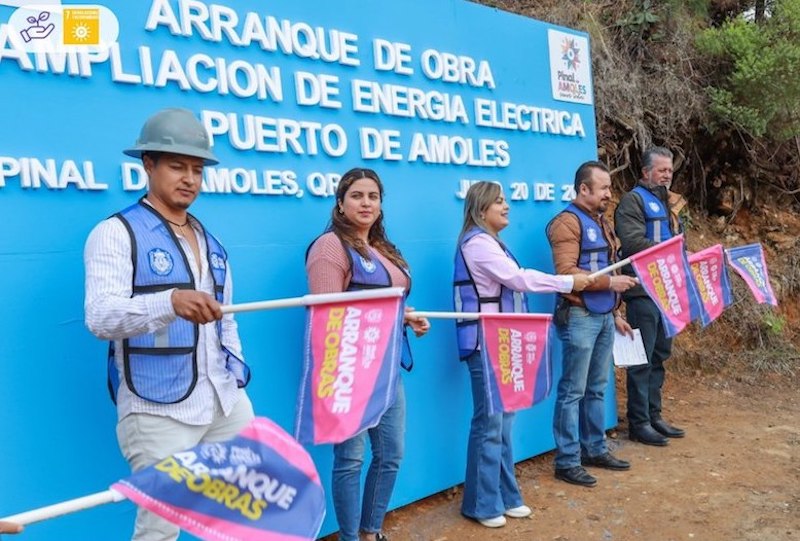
[306,169,430,541]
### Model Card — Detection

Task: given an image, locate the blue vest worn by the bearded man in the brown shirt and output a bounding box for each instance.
[560,203,617,314]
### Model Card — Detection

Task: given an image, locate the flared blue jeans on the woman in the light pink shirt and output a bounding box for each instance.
[461,352,522,520]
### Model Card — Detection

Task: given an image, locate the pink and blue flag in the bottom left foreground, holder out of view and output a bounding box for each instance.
[111,418,325,541]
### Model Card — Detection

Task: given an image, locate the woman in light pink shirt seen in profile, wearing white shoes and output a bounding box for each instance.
[453,182,593,528]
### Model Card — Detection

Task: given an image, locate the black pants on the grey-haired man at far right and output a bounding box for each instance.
[626,297,672,427]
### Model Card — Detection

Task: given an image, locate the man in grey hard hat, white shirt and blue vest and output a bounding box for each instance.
[84,109,253,541]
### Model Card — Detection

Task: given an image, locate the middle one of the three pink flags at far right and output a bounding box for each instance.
[689,244,733,327]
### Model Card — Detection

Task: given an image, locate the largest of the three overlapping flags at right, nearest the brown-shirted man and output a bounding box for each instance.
[630,235,703,336]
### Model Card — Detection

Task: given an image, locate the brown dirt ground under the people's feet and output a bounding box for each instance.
[329,373,800,541]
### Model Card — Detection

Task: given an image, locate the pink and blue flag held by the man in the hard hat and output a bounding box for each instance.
[295,290,404,444]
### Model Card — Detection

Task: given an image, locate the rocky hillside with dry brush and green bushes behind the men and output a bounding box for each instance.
[481,0,800,377]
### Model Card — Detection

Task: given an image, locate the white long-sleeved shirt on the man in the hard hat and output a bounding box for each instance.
[84,213,244,425]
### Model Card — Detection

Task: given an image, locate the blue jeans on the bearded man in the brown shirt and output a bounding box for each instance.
[553,306,614,469]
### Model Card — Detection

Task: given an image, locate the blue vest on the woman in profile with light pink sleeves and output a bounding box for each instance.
[453,227,528,359]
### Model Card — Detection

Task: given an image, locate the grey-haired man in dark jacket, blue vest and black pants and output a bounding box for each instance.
[614,147,685,446]
